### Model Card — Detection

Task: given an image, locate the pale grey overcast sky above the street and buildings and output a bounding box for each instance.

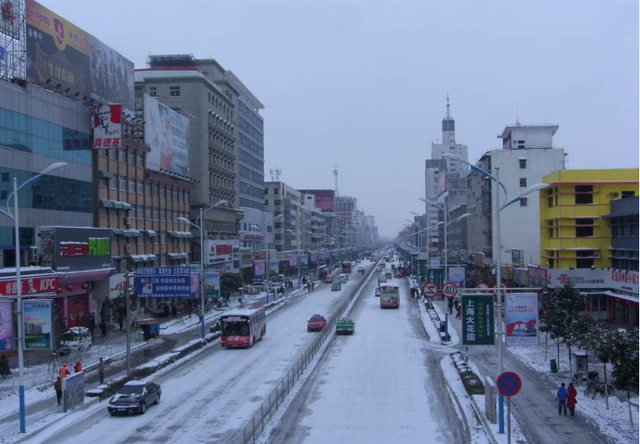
[56,0,638,236]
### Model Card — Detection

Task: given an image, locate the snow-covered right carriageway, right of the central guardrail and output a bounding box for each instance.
[269,265,470,444]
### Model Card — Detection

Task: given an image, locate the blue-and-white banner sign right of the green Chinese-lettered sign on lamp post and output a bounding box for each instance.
[505,293,538,345]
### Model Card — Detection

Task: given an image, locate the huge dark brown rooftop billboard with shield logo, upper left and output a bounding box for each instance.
[25,0,135,112]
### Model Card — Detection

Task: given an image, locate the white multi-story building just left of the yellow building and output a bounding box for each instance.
[466,124,565,264]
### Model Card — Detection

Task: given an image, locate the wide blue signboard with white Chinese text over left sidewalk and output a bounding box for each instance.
[136,267,192,298]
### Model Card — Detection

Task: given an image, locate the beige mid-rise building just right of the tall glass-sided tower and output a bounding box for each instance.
[264,182,302,251]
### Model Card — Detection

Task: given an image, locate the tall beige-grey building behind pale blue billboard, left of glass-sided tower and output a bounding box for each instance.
[135,55,242,246]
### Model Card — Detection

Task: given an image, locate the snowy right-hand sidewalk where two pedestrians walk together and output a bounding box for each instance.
[435,301,637,444]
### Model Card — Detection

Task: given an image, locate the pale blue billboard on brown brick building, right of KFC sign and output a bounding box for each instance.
[143,94,189,176]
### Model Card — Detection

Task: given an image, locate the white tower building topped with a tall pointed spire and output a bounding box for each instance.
[425,95,469,244]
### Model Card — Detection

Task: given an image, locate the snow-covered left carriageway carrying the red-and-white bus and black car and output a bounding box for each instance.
[32,263,372,444]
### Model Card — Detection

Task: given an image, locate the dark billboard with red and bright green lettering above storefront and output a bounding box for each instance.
[36,227,113,271]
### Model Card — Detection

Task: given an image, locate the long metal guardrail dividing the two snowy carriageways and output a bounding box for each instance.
[231,260,375,444]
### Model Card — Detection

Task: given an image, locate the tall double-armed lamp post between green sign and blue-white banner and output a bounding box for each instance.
[442,153,549,433]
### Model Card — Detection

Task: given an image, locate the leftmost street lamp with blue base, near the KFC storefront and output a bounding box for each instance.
[0,162,67,433]
